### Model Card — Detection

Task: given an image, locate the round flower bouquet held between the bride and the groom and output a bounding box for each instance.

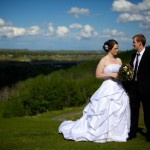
[118,64,134,81]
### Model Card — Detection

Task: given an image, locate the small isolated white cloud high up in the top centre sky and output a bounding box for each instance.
[68,7,90,18]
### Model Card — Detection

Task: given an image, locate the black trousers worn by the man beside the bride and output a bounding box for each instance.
[129,82,150,137]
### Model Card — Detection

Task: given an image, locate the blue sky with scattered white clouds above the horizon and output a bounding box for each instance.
[0,0,150,50]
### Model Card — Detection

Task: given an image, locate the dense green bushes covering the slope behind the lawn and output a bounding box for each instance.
[0,62,100,117]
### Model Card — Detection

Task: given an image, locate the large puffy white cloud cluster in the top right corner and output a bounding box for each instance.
[112,0,150,29]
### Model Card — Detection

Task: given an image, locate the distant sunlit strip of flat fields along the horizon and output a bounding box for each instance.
[0,49,104,62]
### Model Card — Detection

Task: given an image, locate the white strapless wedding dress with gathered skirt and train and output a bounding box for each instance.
[58,64,130,143]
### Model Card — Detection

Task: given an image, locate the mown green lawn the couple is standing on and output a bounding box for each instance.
[0,106,150,150]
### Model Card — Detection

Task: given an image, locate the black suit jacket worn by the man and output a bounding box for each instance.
[130,49,150,95]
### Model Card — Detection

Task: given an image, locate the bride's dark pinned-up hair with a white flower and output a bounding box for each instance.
[103,39,118,52]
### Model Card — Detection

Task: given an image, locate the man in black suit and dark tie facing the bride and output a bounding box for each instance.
[128,34,150,142]
